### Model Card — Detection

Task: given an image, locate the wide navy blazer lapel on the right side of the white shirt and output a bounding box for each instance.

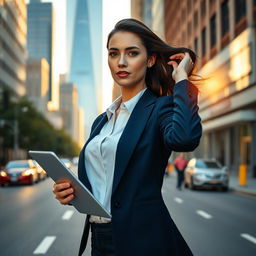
[112,89,157,194]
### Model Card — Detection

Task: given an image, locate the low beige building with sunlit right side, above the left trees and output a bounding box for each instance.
[26,58,49,114]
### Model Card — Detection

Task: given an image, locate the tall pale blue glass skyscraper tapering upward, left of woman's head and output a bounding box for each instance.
[67,0,98,136]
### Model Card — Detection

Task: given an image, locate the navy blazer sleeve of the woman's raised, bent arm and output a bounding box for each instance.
[158,79,202,152]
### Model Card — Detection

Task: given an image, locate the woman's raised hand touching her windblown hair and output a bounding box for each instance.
[167,52,194,83]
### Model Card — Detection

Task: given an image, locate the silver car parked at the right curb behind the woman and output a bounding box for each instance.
[184,158,229,191]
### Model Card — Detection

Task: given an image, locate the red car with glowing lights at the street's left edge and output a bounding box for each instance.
[0,159,39,186]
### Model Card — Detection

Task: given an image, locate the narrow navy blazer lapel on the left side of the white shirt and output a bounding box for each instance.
[78,113,108,192]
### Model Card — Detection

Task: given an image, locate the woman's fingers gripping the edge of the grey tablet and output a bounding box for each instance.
[53,182,74,204]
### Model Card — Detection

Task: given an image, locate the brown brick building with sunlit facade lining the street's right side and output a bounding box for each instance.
[164,0,256,177]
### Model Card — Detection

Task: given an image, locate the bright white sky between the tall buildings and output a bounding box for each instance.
[26,0,131,112]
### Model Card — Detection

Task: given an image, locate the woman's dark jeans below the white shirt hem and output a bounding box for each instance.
[91,223,115,256]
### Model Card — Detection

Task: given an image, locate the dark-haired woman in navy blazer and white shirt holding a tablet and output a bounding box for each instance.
[54,19,202,256]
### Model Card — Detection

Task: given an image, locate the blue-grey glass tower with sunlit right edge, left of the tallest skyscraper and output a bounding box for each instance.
[27,0,59,110]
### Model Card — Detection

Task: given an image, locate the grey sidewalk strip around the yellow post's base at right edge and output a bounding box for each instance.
[229,176,256,196]
